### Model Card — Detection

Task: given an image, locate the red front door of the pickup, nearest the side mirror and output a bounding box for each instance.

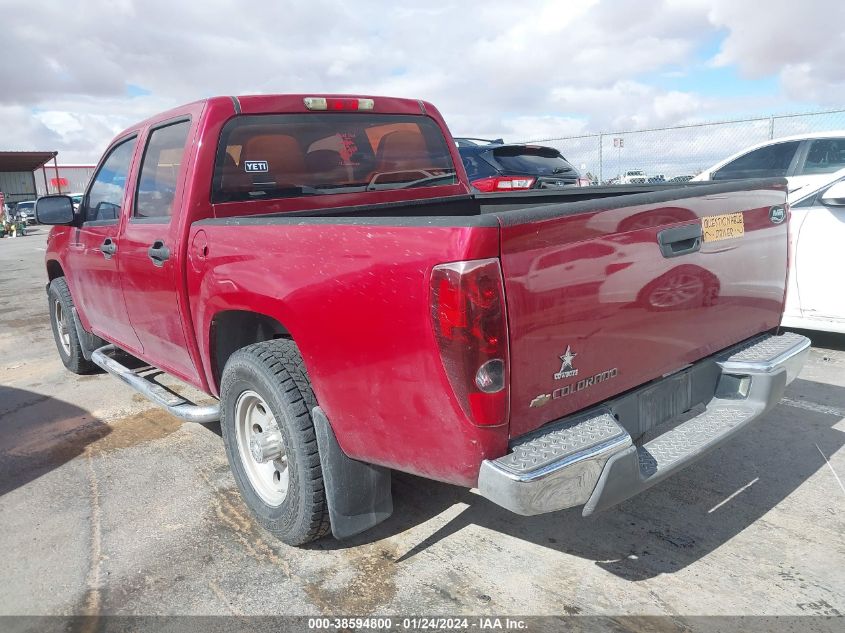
[67,135,143,353]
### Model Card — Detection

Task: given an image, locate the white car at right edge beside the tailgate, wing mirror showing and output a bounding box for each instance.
[782,169,845,334]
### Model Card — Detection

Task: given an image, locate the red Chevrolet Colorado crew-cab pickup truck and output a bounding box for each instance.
[37,95,809,544]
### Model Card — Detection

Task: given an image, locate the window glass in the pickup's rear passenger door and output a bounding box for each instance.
[133,121,191,222]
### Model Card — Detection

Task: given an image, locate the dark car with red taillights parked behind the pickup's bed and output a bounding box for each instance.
[455,137,581,193]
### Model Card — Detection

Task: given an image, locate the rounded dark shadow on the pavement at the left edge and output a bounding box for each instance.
[0,386,111,496]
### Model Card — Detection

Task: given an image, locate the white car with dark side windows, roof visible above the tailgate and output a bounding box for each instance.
[692,130,845,200]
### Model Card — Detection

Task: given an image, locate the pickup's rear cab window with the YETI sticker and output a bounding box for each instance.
[212,113,457,202]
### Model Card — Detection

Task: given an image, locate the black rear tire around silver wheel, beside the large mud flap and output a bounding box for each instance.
[220,339,330,545]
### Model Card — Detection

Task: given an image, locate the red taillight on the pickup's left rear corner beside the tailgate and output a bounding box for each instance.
[431,259,509,426]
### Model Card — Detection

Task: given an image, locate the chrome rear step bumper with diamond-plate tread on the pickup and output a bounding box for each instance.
[478,333,810,516]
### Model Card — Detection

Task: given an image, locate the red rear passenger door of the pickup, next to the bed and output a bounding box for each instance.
[121,117,198,384]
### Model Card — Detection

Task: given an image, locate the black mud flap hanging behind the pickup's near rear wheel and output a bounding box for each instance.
[311,407,393,539]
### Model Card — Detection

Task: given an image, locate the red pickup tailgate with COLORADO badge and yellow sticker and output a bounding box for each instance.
[499,179,787,436]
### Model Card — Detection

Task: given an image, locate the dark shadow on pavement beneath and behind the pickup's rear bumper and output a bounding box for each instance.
[322,379,845,581]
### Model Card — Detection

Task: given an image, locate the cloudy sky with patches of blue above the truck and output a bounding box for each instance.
[0,0,845,163]
